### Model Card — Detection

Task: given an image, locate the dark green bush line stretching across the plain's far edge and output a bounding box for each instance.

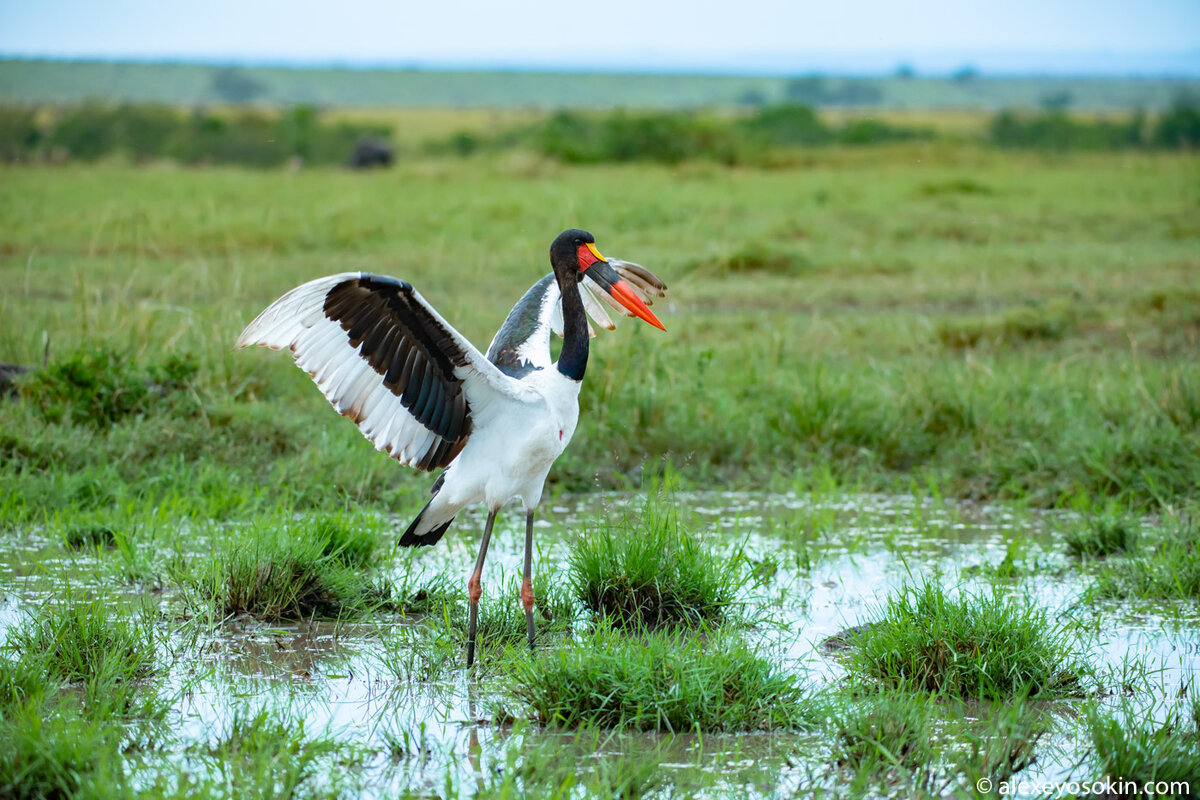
[0,98,1200,167]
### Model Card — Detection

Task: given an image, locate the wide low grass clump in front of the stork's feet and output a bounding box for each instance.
[511,626,815,732]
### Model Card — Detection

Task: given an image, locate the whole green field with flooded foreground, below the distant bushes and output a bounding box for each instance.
[0,128,1200,798]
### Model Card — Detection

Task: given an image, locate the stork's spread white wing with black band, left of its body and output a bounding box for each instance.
[238,272,524,470]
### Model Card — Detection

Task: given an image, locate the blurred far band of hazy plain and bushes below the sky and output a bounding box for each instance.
[0,60,1200,167]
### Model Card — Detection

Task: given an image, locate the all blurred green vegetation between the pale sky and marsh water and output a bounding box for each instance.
[0,62,1200,522]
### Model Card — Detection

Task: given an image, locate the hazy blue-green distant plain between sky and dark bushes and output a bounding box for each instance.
[0,60,1198,110]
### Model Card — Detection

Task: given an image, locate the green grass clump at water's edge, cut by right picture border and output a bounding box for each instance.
[1092,510,1200,602]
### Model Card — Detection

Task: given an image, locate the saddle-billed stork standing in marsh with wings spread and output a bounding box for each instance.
[238,229,666,667]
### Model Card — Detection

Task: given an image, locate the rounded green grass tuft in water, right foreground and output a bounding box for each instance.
[846,579,1091,700]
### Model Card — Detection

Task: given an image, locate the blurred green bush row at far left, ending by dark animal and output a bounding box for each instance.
[0,103,391,167]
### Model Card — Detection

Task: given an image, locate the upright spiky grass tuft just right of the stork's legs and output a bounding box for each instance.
[570,500,749,628]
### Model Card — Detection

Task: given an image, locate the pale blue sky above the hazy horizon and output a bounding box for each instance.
[0,0,1200,71]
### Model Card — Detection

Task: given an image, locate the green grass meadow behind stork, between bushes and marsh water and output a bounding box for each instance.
[0,148,1200,525]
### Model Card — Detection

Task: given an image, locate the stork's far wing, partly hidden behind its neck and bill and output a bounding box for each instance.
[487,258,667,378]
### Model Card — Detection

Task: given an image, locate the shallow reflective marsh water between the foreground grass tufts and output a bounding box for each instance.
[0,492,1200,798]
